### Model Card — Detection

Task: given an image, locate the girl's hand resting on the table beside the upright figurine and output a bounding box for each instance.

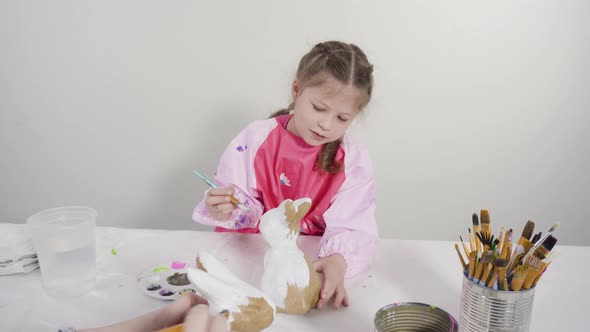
[313,254,348,309]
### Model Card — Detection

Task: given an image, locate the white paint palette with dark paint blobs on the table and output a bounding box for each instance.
[137,261,197,300]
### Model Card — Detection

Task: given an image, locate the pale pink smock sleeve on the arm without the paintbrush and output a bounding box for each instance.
[318,135,379,278]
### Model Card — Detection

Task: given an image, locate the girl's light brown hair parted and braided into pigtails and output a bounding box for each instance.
[270,41,373,174]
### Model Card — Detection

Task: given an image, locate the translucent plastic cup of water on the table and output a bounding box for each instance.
[27,206,97,297]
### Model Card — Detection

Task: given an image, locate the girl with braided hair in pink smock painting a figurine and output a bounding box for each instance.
[193,41,378,309]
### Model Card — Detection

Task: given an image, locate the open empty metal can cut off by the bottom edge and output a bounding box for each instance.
[373,302,459,332]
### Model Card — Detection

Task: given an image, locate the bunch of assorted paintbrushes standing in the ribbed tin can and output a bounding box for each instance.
[455,210,559,291]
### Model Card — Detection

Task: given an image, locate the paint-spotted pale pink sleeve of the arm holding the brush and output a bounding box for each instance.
[193,119,276,229]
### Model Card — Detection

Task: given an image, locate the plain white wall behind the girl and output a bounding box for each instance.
[0,0,590,245]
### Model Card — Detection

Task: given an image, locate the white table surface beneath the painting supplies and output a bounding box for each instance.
[0,226,590,332]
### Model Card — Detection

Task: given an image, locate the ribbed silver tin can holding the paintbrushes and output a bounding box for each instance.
[459,274,535,332]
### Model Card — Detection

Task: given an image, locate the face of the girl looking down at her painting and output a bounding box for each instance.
[287,77,360,146]
